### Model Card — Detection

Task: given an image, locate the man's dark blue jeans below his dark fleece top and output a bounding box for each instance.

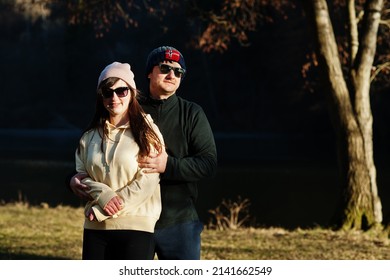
[154,221,203,260]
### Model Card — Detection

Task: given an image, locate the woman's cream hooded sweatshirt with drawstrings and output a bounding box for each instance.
[76,115,163,232]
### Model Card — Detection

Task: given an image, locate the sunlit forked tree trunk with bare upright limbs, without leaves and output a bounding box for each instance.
[308,0,383,229]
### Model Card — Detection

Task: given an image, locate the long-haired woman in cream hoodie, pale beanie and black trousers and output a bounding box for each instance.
[76,62,163,259]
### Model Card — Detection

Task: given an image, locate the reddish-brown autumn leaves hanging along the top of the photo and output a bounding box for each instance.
[15,0,390,98]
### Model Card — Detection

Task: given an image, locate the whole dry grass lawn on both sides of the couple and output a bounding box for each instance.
[0,203,390,260]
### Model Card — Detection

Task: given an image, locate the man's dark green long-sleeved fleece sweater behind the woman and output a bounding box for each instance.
[140,94,217,229]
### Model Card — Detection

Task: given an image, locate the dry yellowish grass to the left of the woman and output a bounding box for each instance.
[0,203,83,259]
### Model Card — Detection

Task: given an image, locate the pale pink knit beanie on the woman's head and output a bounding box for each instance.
[98,62,137,89]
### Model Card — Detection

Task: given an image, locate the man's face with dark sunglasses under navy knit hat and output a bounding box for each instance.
[148,61,181,99]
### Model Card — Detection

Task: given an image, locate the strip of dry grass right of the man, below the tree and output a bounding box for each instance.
[202,228,390,260]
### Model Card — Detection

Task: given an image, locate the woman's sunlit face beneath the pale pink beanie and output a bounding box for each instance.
[103,80,131,121]
